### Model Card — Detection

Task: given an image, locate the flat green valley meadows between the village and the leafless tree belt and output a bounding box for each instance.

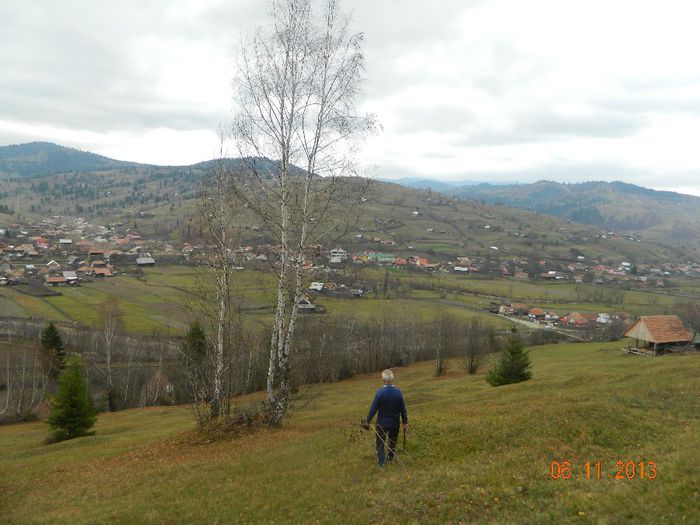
[0,266,700,333]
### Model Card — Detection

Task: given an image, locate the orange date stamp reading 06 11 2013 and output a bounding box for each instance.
[549,460,658,480]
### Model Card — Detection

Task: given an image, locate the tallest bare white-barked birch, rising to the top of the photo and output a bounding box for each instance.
[233,0,374,425]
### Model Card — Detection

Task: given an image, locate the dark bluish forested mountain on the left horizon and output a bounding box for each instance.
[0,142,143,178]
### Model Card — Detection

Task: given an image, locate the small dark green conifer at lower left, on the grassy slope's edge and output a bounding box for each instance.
[48,356,97,442]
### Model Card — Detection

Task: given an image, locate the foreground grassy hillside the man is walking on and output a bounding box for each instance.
[0,343,700,524]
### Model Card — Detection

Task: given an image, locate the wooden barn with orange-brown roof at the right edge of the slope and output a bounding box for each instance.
[623,315,693,354]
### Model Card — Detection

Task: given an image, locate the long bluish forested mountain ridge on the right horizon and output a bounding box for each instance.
[452,181,700,250]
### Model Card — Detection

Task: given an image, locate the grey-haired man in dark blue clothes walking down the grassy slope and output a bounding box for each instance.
[363,369,408,467]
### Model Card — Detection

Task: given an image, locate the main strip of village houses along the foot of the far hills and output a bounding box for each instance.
[0,216,700,289]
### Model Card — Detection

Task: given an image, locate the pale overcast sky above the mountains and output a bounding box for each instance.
[0,0,700,195]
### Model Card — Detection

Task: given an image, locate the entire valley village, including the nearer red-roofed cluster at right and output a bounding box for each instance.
[0,216,700,352]
